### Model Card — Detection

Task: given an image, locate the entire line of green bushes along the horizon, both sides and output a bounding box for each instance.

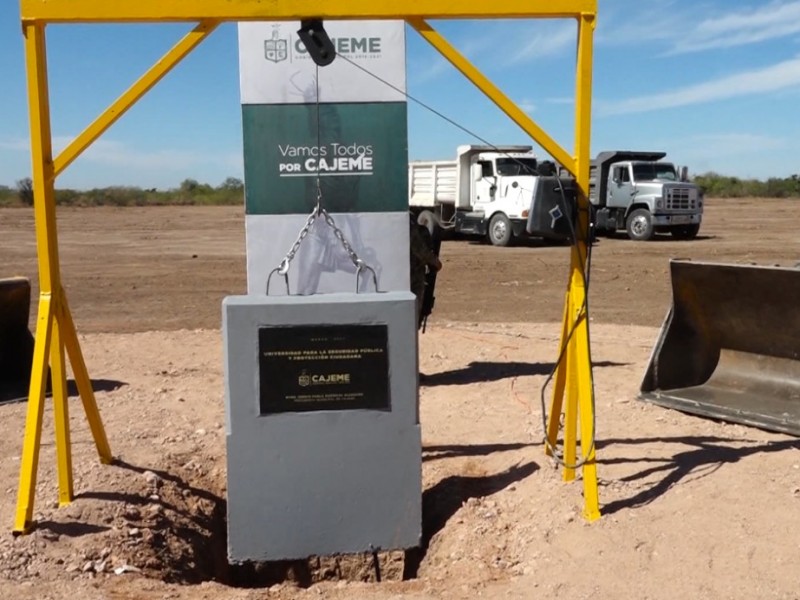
[0,173,800,206]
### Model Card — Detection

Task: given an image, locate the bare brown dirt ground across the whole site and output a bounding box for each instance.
[0,199,800,600]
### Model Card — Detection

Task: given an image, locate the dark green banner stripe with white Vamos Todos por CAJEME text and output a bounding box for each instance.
[242,102,408,215]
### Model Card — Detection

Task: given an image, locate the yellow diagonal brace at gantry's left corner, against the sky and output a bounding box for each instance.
[53,20,219,177]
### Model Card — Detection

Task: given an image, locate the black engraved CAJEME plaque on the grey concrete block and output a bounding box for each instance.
[258,324,390,415]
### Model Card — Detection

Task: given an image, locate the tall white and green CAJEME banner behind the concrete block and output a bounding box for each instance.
[239,21,409,294]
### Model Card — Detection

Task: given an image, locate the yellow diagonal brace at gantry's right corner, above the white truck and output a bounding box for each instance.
[408,19,575,173]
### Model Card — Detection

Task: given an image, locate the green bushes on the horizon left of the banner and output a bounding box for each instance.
[0,177,244,206]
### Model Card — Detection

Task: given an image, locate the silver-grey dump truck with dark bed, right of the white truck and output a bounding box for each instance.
[589,150,703,241]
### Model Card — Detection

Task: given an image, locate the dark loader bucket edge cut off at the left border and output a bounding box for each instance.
[0,277,33,402]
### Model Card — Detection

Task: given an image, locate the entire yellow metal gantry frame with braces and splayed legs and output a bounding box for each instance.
[14,0,600,533]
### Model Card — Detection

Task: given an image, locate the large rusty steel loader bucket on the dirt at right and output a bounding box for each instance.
[640,260,800,435]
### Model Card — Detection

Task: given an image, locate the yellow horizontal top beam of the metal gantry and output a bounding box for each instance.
[20,0,597,23]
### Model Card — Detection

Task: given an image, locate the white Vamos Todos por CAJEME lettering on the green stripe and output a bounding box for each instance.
[278,142,374,177]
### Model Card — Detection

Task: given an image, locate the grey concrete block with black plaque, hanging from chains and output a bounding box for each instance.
[223,292,422,562]
